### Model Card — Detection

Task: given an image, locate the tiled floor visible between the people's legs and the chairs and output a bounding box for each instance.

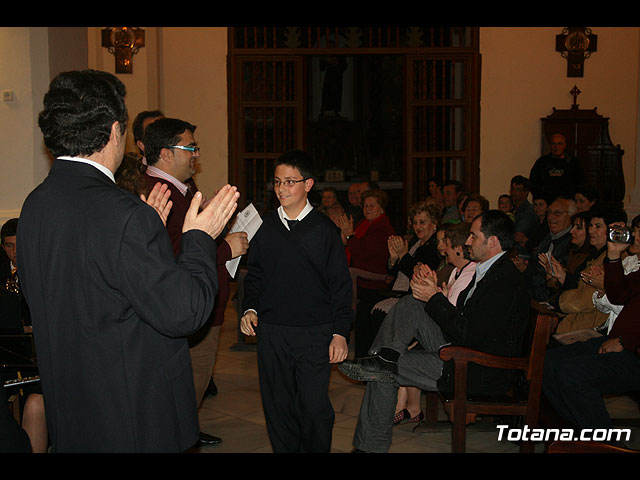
[189,284,640,453]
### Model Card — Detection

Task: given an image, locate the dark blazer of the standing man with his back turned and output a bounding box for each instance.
[17,159,217,452]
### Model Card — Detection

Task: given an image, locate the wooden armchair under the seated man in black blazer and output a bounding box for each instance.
[426,308,557,453]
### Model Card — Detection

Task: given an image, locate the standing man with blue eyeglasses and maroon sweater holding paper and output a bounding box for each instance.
[143,118,249,446]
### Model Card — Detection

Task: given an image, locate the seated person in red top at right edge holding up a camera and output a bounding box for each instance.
[542,227,640,429]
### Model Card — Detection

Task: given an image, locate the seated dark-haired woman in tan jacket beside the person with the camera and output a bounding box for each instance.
[556,204,627,333]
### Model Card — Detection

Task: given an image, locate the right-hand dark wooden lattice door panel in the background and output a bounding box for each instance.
[405,54,479,205]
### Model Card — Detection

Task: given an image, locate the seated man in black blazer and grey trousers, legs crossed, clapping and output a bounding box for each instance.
[339,210,529,452]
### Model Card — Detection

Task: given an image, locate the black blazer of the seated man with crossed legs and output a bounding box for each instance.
[425,254,530,395]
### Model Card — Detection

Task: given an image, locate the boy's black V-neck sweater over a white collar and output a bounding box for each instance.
[244,209,353,338]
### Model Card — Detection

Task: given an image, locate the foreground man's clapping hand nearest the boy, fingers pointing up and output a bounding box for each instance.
[182,185,240,238]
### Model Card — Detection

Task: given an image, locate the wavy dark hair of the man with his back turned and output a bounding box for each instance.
[38,70,128,157]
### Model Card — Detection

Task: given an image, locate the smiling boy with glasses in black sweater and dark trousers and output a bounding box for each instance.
[241,150,353,453]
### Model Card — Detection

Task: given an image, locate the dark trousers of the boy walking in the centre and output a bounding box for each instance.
[257,322,335,453]
